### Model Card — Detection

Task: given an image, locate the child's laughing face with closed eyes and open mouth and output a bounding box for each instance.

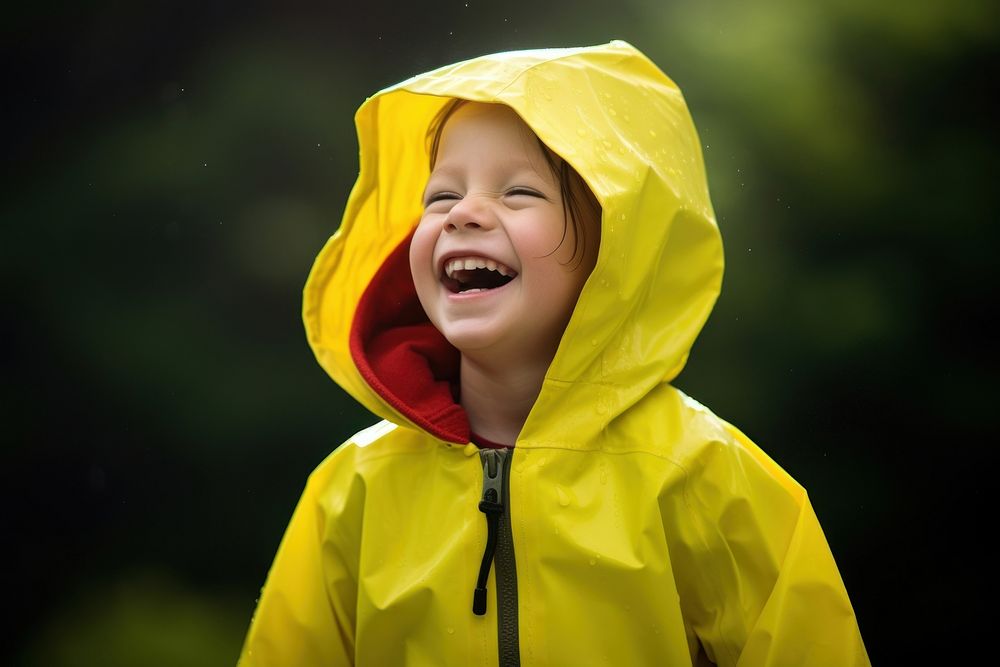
[410,103,600,366]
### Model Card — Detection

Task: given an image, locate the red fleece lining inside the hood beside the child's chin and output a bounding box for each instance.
[350,232,470,443]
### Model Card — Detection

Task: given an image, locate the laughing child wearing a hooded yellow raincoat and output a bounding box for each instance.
[241,42,868,667]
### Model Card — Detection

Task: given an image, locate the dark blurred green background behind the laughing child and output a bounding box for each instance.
[0,0,1000,667]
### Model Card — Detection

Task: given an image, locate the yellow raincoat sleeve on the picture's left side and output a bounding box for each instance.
[238,445,363,667]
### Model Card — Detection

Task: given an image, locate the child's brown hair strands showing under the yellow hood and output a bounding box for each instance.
[427,99,601,269]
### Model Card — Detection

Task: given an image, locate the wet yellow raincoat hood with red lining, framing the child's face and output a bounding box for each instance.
[303,41,723,447]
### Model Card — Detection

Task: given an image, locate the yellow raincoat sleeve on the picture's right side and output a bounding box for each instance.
[682,424,870,667]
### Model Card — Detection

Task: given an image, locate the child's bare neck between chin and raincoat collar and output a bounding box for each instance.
[461,354,548,445]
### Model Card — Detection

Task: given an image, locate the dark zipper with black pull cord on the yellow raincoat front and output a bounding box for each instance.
[472,449,521,667]
